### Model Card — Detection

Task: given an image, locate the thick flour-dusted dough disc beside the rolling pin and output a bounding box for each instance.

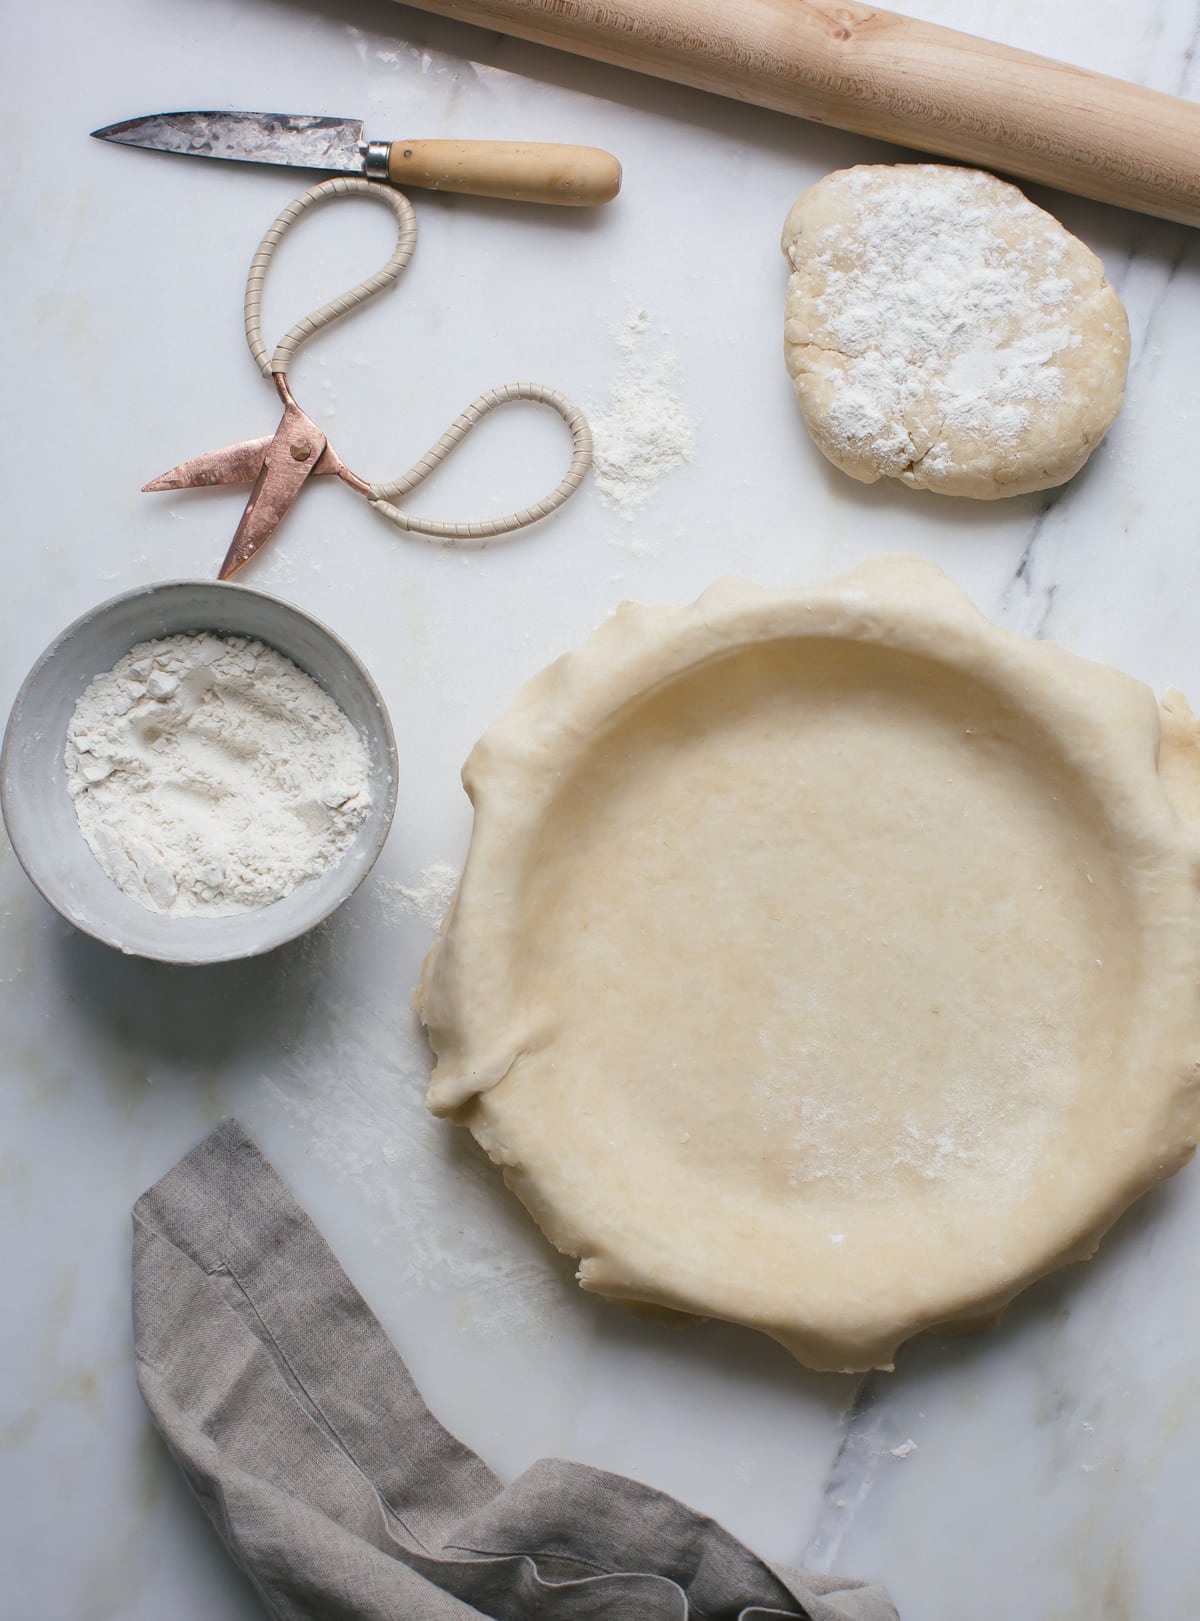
[783,164,1129,501]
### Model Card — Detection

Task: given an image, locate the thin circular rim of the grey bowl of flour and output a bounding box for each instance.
[0,577,399,968]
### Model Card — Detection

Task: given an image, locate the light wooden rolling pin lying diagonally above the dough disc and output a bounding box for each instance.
[400,0,1200,225]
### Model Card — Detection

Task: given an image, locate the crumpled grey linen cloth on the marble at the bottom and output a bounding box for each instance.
[133,1120,897,1621]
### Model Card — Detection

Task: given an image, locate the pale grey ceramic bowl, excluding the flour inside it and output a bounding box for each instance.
[0,580,396,963]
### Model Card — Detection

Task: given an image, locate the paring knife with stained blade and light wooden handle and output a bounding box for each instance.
[92,112,621,206]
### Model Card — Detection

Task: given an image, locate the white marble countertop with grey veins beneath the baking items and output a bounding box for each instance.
[0,0,1200,1621]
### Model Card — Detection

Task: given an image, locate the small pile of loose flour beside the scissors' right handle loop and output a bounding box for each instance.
[589,305,696,521]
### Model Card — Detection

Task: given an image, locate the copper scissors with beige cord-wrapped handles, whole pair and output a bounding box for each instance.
[143,177,592,580]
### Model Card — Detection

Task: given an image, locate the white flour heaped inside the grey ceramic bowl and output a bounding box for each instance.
[65,632,370,916]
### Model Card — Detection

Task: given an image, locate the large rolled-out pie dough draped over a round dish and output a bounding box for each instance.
[417,559,1200,1368]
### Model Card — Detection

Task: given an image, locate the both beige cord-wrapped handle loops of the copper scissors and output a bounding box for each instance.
[245,177,592,541]
